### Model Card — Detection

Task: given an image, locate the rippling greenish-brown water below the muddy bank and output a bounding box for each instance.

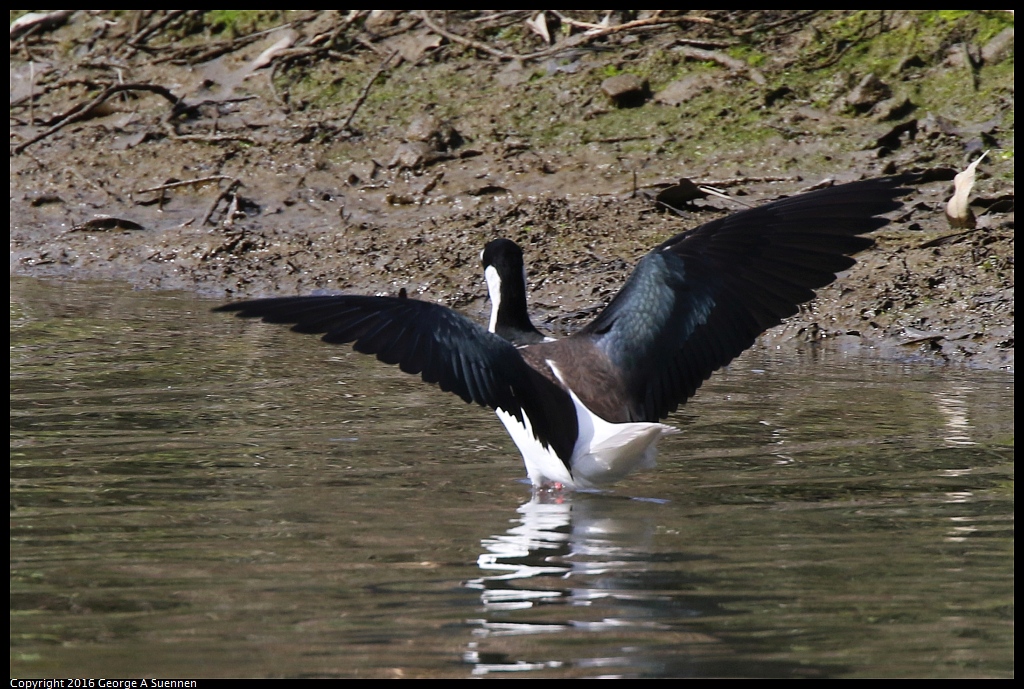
[10,278,1014,678]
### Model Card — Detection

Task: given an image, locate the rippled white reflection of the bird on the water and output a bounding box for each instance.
[463,492,678,675]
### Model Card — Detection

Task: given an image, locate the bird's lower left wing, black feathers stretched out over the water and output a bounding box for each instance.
[214,295,577,466]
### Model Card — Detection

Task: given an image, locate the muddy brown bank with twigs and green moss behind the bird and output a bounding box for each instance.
[10,10,1014,368]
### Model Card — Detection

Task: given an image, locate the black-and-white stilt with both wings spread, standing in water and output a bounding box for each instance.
[217,175,914,488]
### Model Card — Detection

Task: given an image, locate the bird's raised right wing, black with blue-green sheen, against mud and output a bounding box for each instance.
[574,175,915,421]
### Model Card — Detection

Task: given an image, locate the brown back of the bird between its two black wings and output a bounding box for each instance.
[519,337,637,424]
